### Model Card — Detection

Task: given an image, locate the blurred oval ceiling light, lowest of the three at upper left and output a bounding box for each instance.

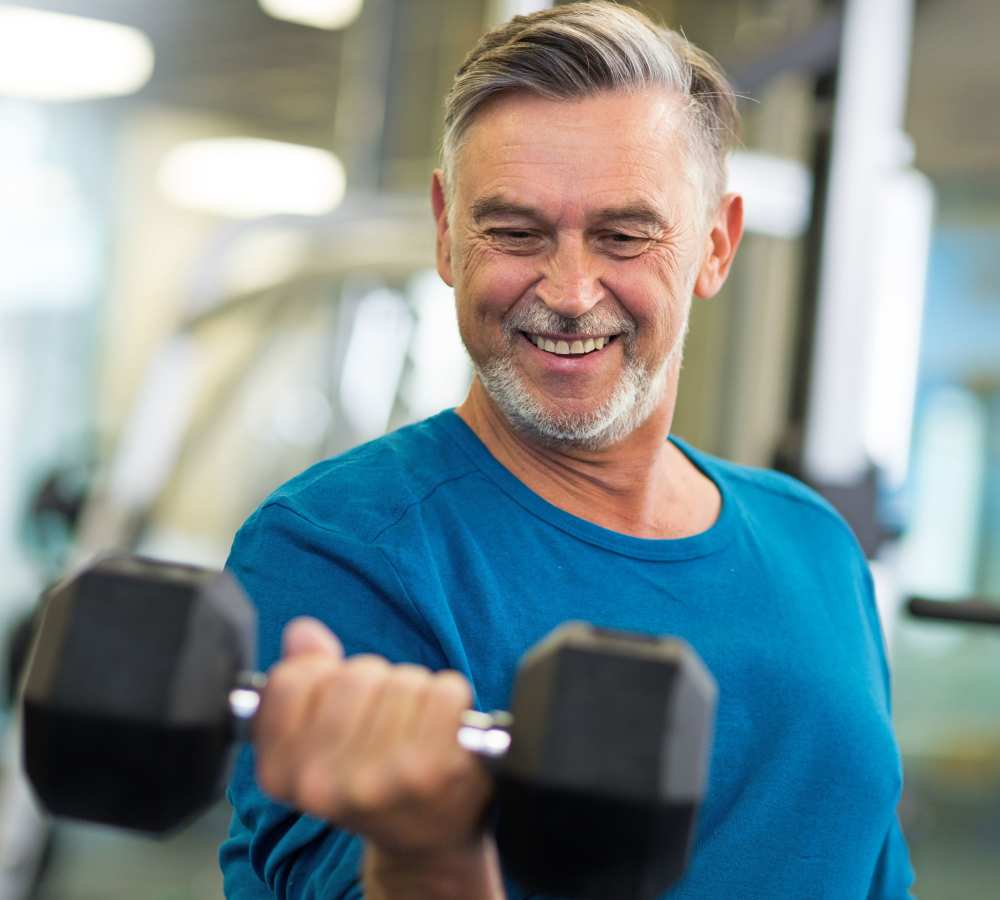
[158,138,347,219]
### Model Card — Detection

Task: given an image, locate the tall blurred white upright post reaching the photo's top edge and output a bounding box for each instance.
[803,0,930,484]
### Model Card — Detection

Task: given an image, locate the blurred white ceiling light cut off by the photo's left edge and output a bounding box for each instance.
[0,5,153,100]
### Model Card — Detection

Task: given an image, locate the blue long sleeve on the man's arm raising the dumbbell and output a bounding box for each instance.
[220,504,444,900]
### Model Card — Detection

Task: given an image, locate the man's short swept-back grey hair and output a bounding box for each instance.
[441,0,739,220]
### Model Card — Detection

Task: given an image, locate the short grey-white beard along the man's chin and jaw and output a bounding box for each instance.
[473,315,689,451]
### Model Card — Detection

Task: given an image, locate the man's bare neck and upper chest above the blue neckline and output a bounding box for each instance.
[457,381,721,539]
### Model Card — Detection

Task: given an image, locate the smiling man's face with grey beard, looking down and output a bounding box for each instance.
[439,91,706,449]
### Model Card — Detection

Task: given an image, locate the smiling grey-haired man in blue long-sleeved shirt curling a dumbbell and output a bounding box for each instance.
[222,2,912,900]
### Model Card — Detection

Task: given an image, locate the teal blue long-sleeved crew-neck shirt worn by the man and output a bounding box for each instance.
[220,411,913,900]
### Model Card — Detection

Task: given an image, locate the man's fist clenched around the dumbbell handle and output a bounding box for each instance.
[254,619,491,860]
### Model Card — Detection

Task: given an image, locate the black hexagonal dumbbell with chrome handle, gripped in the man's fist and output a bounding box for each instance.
[23,557,716,898]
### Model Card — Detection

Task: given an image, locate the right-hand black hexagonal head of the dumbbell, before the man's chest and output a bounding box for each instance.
[497,622,716,900]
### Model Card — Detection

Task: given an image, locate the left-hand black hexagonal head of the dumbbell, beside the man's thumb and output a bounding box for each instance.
[22,557,256,832]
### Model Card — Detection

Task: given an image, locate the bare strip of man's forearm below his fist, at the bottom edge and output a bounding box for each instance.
[362,835,507,900]
